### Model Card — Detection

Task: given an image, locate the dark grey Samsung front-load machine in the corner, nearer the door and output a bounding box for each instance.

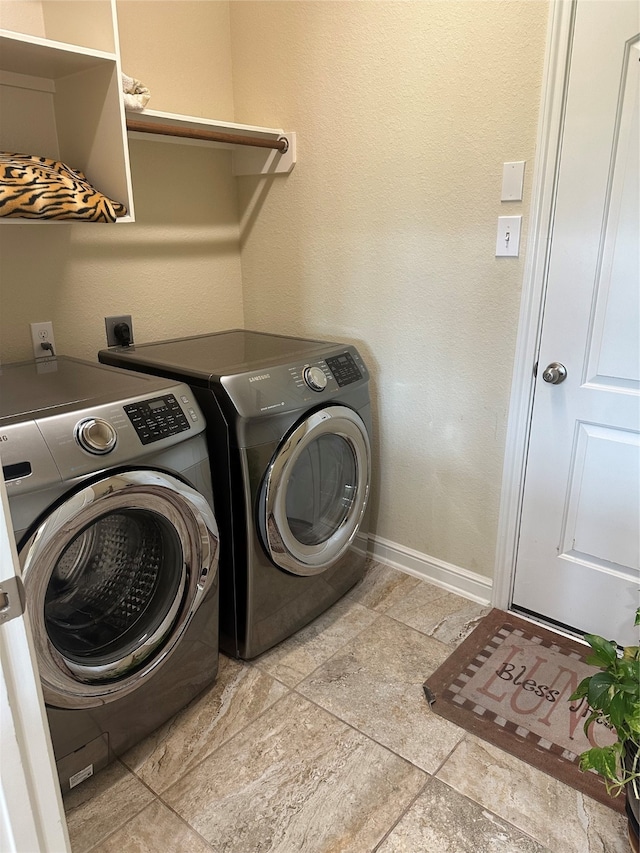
[99,329,371,658]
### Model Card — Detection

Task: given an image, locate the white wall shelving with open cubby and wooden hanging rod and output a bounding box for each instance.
[0,0,296,224]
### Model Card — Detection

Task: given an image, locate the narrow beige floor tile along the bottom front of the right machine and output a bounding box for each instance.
[255,598,377,687]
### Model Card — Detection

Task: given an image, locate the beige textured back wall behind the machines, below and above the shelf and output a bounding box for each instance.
[0,0,243,362]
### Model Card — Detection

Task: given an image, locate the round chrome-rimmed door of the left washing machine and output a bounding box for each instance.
[19,470,218,708]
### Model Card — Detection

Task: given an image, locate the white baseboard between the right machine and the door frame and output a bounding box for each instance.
[369,536,493,604]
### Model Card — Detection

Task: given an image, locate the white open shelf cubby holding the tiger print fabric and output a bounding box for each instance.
[0,20,134,225]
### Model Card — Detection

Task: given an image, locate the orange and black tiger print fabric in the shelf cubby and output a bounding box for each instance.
[0,151,127,222]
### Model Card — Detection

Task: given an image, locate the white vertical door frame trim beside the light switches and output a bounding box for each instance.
[491,0,584,610]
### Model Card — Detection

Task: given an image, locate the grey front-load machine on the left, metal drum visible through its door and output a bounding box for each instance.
[0,358,219,794]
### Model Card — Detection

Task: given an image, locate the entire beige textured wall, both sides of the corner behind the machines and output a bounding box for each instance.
[0,0,547,576]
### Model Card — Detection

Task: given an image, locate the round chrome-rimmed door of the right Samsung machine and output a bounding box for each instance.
[259,406,371,576]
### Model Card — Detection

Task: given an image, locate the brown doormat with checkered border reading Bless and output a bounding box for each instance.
[425,609,624,813]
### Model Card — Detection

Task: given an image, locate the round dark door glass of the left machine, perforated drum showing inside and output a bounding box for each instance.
[44,509,186,681]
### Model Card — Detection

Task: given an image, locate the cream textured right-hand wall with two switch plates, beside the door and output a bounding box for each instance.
[231,0,547,576]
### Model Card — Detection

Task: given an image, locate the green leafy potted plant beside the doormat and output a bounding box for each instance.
[570,607,640,851]
